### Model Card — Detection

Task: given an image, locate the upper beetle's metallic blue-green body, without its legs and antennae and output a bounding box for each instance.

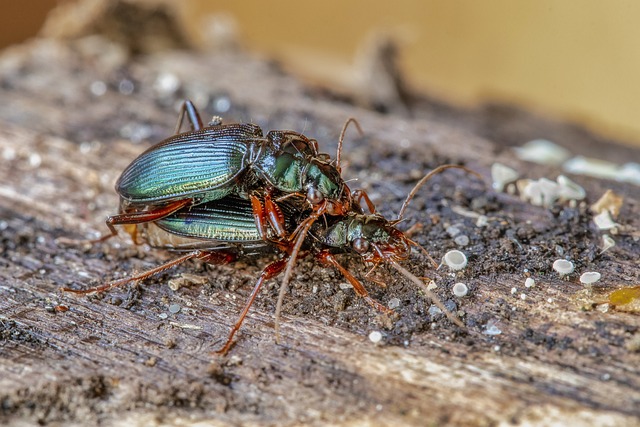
[116,120,351,214]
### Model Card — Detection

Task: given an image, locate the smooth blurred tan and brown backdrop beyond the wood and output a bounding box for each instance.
[0,0,640,145]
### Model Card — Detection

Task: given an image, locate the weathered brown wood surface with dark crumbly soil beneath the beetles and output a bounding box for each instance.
[0,1,640,426]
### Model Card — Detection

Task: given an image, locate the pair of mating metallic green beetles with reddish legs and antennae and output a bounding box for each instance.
[64,101,473,353]
